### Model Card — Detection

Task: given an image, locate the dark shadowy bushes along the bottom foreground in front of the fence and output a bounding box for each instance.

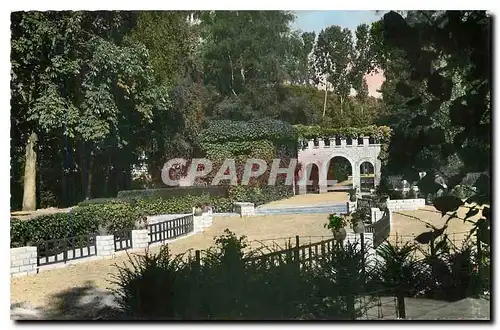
[112,229,489,320]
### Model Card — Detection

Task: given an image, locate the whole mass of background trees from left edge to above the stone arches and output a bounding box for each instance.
[11,11,384,210]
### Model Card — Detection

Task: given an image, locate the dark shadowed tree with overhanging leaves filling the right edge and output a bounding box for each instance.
[381,11,491,248]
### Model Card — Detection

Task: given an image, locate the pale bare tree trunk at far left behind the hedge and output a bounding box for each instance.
[23,132,38,211]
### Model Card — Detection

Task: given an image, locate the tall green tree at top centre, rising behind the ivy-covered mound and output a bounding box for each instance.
[201,11,293,120]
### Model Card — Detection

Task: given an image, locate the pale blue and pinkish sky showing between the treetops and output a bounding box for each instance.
[292,10,384,97]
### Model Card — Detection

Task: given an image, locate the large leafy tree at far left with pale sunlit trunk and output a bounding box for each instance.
[11,11,162,210]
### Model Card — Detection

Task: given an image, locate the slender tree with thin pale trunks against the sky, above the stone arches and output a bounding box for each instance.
[314,26,353,116]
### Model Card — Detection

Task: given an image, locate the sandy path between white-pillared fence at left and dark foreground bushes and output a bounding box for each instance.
[11,214,331,307]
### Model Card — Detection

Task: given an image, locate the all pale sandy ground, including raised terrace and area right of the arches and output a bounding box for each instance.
[11,201,480,307]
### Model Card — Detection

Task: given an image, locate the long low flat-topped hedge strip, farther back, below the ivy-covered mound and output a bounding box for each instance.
[117,186,229,199]
